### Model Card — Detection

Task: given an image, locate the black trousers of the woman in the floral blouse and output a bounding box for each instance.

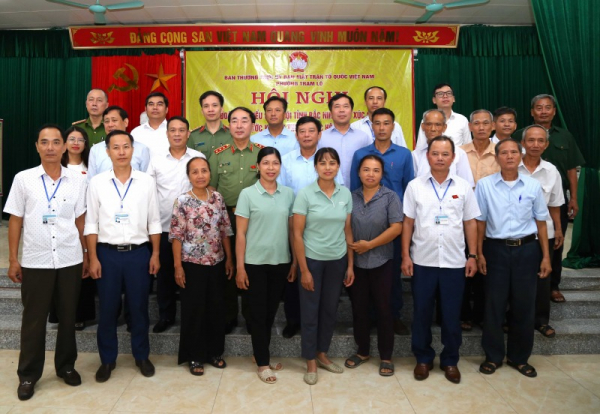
[177,262,227,364]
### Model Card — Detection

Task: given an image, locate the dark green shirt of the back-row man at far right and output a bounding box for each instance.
[512,125,585,191]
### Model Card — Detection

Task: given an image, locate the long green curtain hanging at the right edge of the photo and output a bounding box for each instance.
[531,0,600,269]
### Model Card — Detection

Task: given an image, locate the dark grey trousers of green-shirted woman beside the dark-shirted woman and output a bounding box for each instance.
[298,256,348,360]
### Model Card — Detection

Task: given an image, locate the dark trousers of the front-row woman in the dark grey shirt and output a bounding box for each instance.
[348,260,394,360]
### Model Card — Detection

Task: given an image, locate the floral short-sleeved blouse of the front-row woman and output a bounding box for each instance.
[169,191,233,266]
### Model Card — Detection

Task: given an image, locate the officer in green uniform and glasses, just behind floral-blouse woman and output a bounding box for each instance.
[209,107,263,333]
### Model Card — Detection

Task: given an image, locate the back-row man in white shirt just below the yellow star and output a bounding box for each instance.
[131,92,169,156]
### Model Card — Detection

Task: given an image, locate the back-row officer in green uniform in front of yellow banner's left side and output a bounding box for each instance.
[188,91,233,160]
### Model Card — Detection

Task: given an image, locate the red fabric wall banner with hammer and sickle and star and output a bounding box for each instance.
[92,52,181,131]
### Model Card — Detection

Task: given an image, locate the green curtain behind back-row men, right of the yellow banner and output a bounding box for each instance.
[415,25,551,139]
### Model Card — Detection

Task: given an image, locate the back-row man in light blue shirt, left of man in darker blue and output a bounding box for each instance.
[319,93,372,187]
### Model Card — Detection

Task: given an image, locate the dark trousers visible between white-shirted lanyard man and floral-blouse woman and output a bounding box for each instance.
[156,233,177,322]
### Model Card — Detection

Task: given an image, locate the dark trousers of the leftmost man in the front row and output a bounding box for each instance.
[17,263,83,383]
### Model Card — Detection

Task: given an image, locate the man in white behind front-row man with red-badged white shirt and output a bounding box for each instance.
[412,109,475,188]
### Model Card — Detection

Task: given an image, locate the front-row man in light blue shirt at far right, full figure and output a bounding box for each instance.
[475,139,551,377]
